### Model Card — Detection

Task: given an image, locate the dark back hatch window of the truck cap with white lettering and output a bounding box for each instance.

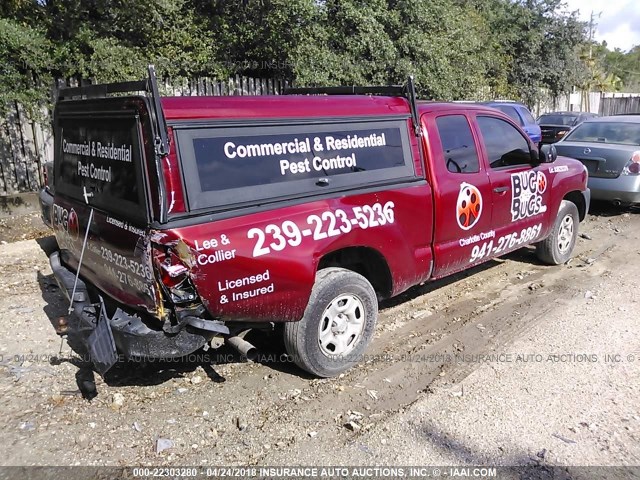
[54,115,147,221]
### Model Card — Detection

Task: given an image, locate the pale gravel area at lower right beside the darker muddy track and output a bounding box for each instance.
[262,235,640,465]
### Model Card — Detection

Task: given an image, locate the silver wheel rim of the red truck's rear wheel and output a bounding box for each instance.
[318,294,365,357]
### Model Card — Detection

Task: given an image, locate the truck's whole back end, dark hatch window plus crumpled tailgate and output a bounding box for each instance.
[52,97,158,313]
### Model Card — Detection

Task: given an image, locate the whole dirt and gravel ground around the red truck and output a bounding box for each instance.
[0,200,640,472]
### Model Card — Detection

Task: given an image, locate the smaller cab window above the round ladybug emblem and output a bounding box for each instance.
[436,115,480,173]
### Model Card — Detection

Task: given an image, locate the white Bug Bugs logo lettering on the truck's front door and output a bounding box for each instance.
[511,170,547,222]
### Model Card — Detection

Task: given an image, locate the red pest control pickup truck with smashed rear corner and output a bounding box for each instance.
[49,69,589,377]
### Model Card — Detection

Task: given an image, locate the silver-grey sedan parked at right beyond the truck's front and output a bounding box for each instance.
[555,115,640,205]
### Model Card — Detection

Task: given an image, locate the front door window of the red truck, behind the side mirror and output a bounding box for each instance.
[477,117,531,168]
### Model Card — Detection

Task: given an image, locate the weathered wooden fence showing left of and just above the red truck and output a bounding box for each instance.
[0,75,288,196]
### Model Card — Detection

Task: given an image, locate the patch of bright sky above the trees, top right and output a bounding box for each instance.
[565,0,640,52]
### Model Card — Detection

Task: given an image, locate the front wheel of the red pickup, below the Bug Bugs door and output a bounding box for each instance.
[536,200,580,265]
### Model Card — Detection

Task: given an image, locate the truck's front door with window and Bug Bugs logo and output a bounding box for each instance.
[476,114,550,249]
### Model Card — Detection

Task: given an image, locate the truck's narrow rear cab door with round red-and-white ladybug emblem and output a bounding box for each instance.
[422,112,495,277]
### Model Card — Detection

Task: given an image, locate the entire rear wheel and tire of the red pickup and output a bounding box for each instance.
[284,268,378,377]
